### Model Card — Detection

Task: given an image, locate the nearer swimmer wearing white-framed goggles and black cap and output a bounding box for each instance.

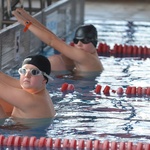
[0,55,55,119]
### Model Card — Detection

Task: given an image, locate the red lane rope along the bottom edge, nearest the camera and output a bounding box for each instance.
[0,135,150,150]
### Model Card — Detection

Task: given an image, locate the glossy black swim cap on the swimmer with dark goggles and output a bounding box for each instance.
[74,24,97,47]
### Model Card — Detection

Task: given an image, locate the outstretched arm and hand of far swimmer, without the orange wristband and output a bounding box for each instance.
[13,9,89,62]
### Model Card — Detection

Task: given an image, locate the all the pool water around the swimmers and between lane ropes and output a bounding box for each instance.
[0,20,150,143]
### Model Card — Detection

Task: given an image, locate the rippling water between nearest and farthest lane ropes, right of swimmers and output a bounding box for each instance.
[47,57,150,142]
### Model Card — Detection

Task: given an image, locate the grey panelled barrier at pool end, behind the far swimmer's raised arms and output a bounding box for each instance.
[0,0,84,71]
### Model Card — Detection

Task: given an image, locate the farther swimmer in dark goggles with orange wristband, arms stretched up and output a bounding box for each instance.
[13,8,104,76]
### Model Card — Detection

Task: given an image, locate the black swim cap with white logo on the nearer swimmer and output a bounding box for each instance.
[22,55,51,81]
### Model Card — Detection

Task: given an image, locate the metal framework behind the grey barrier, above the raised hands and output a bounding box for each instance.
[0,0,52,29]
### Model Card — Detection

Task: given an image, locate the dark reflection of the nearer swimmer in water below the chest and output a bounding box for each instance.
[0,118,53,138]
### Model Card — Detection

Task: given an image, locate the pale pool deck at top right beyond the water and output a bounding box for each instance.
[85,0,150,21]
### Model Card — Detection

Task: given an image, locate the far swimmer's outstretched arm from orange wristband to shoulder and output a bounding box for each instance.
[21,20,86,62]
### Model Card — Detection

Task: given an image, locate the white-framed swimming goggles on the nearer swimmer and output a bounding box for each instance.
[18,68,53,80]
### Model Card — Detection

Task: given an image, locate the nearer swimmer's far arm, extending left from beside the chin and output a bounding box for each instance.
[0,72,21,88]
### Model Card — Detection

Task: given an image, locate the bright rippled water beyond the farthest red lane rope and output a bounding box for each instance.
[88,20,150,48]
